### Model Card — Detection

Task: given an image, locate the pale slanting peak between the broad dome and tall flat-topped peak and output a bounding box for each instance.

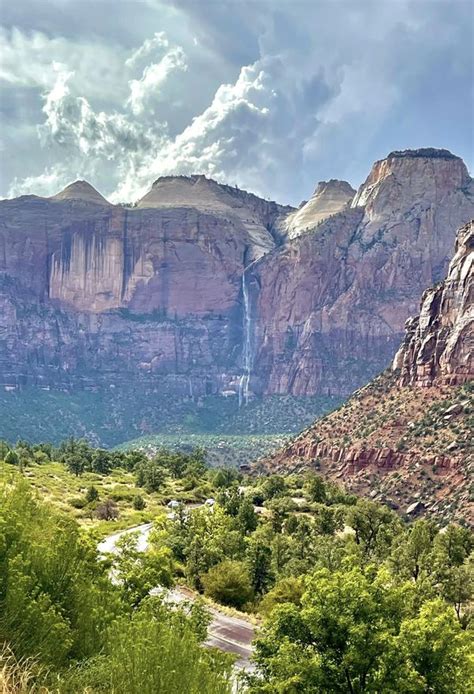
[286,179,355,238]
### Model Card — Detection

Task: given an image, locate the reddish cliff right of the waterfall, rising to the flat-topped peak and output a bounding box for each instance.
[248,150,474,395]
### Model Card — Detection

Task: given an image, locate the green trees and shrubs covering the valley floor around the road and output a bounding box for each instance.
[0,441,474,694]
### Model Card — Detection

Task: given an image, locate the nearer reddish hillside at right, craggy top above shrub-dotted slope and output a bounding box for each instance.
[259,221,474,523]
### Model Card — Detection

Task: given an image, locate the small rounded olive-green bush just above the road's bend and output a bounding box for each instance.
[202,559,253,608]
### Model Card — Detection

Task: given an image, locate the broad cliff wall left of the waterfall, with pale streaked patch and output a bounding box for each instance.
[0,177,291,397]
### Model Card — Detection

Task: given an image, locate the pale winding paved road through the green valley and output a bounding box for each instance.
[98,523,255,670]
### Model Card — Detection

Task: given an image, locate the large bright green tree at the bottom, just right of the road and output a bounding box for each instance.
[255,569,410,694]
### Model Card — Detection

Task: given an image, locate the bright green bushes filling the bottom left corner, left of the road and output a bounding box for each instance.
[0,481,231,694]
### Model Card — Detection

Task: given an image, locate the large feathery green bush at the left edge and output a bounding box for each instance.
[0,482,118,666]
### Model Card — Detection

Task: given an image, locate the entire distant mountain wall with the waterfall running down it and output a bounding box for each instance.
[0,150,474,442]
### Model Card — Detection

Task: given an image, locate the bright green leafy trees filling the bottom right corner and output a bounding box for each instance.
[250,567,473,694]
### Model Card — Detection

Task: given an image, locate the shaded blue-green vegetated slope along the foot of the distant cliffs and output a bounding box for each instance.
[0,385,340,448]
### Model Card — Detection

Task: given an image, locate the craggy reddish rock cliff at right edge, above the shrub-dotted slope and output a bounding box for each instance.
[394,222,474,386]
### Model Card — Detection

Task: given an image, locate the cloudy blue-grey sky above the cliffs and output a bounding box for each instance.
[0,0,474,205]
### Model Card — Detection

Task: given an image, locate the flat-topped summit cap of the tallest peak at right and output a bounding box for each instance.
[352,148,471,214]
